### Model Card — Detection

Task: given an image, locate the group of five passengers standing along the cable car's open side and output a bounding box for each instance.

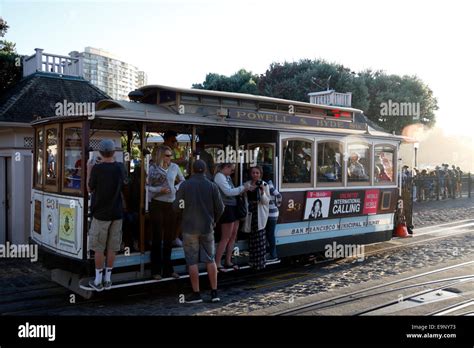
[88,132,281,303]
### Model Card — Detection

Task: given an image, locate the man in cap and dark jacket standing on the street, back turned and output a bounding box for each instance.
[173,160,224,303]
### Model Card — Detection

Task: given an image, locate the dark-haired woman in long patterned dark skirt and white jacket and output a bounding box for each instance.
[244,166,270,270]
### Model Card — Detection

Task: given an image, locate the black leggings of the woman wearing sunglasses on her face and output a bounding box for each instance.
[150,200,177,277]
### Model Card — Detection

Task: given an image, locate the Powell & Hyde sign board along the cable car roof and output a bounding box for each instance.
[228,109,367,130]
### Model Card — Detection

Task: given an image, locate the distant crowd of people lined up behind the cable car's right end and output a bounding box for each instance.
[402,163,463,202]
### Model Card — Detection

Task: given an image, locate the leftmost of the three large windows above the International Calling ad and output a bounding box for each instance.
[282,140,313,184]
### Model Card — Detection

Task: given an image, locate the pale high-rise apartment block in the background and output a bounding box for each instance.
[69,47,147,100]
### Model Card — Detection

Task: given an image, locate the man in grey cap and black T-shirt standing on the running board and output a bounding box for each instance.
[87,139,128,291]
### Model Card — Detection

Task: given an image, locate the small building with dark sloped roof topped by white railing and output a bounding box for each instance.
[0,48,110,244]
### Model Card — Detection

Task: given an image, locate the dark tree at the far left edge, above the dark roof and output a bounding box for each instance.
[0,17,22,94]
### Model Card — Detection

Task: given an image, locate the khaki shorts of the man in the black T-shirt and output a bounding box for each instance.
[89,218,122,252]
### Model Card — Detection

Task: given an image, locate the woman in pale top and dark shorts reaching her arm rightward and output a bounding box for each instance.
[214,163,255,272]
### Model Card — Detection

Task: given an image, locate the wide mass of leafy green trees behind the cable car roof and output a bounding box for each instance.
[193,59,438,134]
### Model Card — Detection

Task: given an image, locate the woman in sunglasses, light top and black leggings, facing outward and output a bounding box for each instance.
[148,145,184,279]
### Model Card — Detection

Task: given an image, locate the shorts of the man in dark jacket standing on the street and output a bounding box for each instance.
[183,233,216,266]
